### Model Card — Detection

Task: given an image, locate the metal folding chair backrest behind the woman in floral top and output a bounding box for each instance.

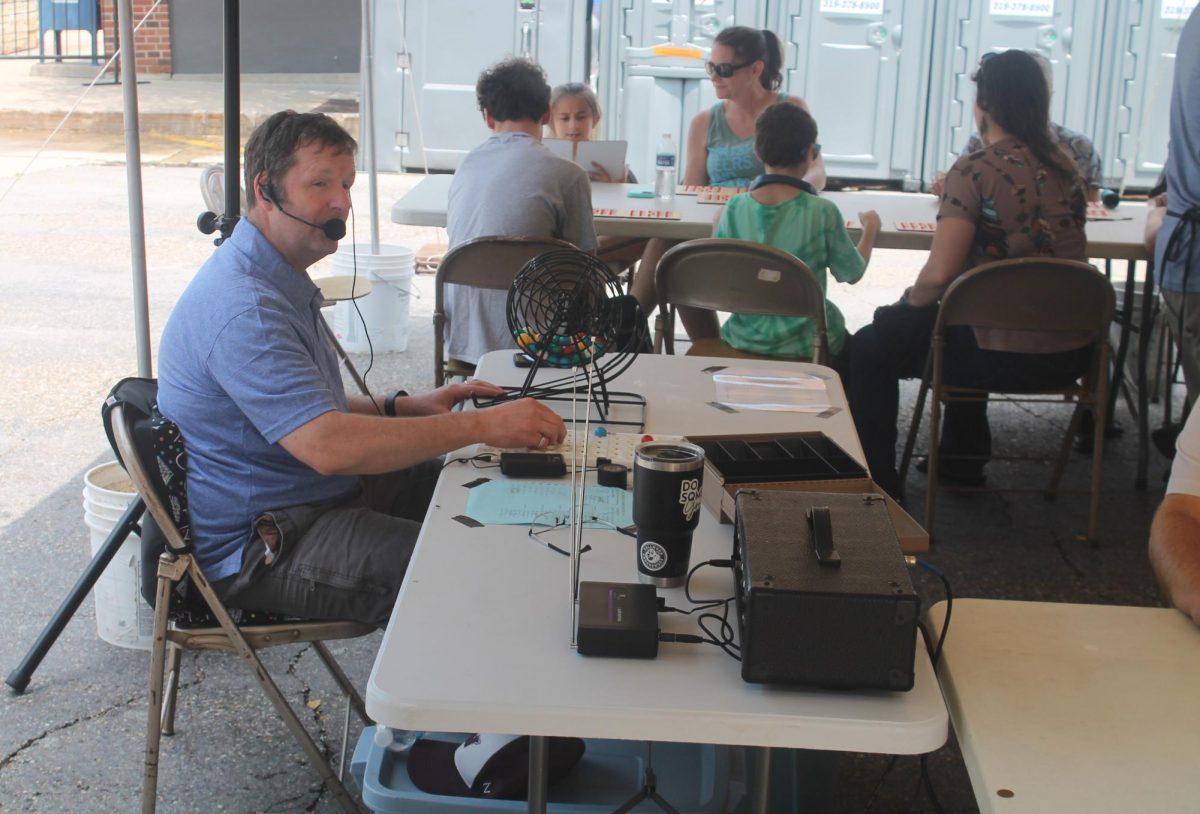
[935,257,1116,341]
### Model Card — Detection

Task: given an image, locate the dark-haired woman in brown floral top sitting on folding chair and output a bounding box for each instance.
[847,50,1088,497]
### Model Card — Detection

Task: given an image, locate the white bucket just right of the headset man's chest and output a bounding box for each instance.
[332,244,416,353]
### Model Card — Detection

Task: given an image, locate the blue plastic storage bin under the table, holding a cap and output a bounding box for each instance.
[350,726,745,814]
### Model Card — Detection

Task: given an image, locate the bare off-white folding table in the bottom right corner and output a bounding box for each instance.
[930,599,1200,814]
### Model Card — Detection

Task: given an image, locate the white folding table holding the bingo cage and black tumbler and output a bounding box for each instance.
[367,352,948,812]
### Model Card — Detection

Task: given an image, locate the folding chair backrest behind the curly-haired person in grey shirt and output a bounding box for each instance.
[433,237,575,385]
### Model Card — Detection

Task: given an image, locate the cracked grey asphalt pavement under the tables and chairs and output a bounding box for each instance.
[0,62,1177,812]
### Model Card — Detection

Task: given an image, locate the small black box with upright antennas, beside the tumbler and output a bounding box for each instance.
[576,582,659,659]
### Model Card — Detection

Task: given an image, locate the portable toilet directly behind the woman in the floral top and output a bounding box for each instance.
[921,0,1104,190]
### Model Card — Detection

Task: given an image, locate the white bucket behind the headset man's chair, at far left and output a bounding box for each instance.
[83,462,154,650]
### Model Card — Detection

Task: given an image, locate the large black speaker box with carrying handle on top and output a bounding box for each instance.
[733,490,920,690]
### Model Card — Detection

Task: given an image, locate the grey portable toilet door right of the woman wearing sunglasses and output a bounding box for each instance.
[782,0,902,179]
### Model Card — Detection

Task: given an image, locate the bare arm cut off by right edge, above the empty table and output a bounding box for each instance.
[1150,493,1200,626]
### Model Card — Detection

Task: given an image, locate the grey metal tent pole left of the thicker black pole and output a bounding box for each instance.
[116,0,154,378]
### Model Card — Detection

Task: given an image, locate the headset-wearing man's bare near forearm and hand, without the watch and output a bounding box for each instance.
[280,396,566,475]
